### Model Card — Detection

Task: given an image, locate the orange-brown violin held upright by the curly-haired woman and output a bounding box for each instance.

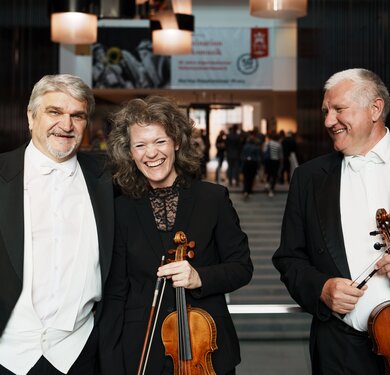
[161,232,217,375]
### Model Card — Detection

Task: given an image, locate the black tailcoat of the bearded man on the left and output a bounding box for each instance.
[0,145,114,334]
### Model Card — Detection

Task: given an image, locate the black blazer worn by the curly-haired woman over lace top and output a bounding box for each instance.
[101,181,253,375]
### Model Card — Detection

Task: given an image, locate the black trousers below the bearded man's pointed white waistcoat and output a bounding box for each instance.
[0,327,99,375]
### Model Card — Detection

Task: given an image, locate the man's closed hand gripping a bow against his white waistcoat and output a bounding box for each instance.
[320,277,367,314]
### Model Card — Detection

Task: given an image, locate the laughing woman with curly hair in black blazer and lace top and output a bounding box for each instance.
[100,96,253,375]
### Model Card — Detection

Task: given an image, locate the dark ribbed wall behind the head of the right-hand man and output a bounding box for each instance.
[297,0,390,160]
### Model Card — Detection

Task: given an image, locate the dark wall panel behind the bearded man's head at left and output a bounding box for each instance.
[0,0,58,152]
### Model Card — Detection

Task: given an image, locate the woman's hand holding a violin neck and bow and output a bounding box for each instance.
[157,260,202,289]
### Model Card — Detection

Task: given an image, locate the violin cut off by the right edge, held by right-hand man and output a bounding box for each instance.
[368,208,390,375]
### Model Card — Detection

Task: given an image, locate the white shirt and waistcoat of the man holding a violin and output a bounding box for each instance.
[340,130,390,331]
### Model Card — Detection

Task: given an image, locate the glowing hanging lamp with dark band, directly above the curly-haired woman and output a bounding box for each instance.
[150,0,194,55]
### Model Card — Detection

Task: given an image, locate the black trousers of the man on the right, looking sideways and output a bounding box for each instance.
[313,317,385,375]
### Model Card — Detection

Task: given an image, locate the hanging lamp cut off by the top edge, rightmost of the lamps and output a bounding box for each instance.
[249,0,307,19]
